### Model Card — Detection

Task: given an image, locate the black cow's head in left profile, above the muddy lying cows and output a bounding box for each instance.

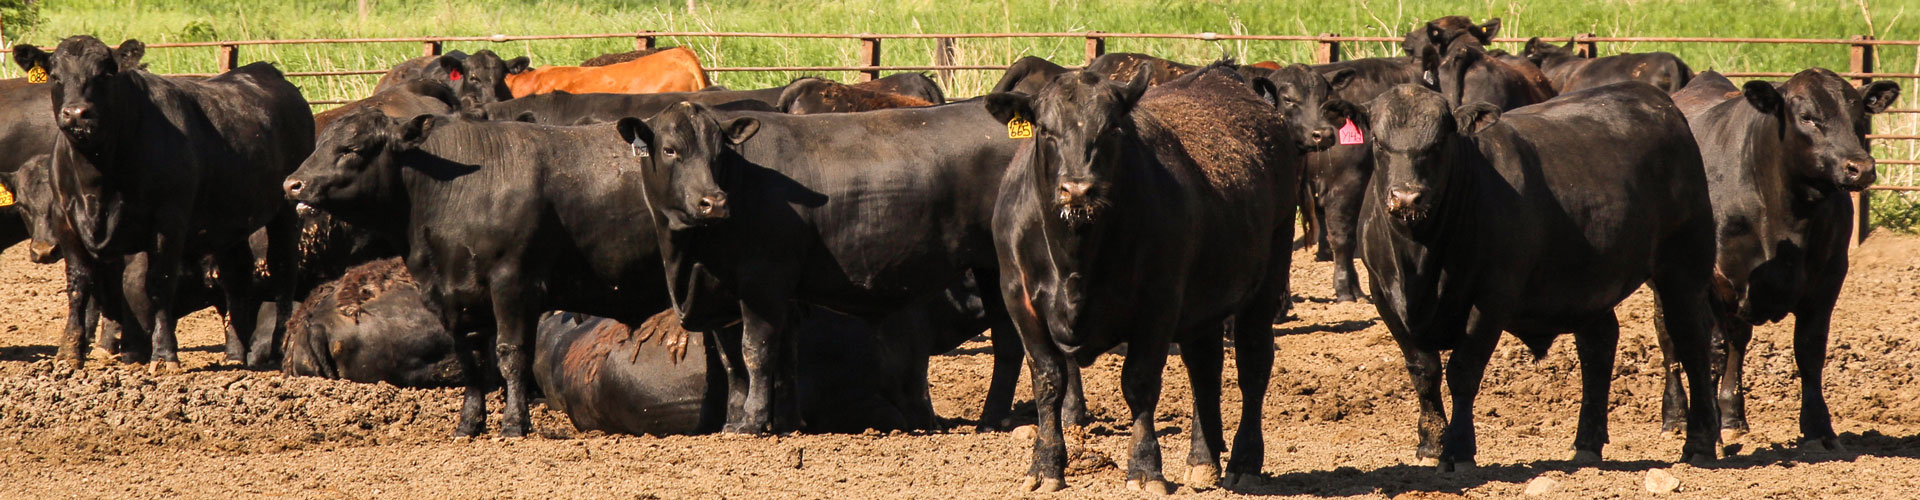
[280,108,430,227]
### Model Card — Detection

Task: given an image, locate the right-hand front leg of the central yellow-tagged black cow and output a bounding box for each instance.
[1119,335,1175,494]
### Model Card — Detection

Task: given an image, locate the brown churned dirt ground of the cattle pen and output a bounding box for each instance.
[0,235,1920,498]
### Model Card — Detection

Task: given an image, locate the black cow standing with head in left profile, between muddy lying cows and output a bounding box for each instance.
[284,110,668,437]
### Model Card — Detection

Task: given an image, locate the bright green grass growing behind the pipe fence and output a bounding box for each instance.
[0,0,1920,229]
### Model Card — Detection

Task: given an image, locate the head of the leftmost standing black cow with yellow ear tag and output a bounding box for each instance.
[13,35,146,150]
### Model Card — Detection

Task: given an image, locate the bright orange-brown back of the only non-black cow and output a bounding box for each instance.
[507,46,708,98]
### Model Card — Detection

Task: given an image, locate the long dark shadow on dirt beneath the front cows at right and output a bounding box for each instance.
[1235,431,1920,496]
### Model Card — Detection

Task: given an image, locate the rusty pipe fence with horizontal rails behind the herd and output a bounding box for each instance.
[0,31,1920,242]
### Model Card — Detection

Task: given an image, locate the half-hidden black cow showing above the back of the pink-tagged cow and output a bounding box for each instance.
[1521,37,1693,92]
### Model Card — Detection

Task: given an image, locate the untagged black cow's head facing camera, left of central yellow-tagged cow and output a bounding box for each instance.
[614,102,760,231]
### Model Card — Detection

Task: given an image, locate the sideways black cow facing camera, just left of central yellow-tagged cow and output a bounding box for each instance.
[620,100,1052,433]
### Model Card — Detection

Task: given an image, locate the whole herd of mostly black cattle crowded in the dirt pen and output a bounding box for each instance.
[0,17,1899,492]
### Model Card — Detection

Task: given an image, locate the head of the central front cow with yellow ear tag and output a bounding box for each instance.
[987,71,1152,227]
